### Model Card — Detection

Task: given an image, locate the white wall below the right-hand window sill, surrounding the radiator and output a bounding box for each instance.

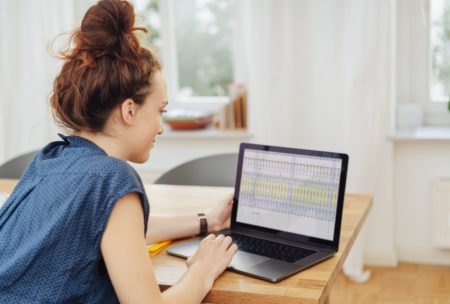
[394,140,450,265]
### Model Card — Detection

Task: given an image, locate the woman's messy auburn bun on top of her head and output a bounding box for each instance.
[78,0,146,56]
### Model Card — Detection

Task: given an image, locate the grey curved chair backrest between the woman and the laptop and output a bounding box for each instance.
[155,153,238,187]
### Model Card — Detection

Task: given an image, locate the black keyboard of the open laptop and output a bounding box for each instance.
[231,233,315,263]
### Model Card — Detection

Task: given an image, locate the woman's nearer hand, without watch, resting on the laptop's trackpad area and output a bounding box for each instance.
[186,234,238,280]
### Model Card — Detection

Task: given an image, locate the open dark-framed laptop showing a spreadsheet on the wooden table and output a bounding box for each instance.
[167,143,348,282]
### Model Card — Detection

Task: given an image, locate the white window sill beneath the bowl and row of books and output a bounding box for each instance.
[158,127,253,140]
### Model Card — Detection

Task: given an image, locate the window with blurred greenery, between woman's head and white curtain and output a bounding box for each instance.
[134,0,234,108]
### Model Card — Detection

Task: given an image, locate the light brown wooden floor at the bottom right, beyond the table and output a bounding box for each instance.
[330,263,450,304]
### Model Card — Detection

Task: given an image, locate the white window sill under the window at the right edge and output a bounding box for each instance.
[389,126,450,142]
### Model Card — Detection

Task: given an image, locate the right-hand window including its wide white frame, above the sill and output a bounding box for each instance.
[396,0,450,126]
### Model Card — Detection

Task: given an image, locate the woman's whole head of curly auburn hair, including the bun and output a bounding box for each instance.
[50,0,161,132]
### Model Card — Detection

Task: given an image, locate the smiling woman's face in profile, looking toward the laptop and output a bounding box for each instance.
[129,71,167,163]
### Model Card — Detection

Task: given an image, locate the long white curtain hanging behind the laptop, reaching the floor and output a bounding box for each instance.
[236,0,395,280]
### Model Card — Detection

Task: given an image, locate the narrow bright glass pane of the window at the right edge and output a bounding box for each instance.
[430,0,450,102]
